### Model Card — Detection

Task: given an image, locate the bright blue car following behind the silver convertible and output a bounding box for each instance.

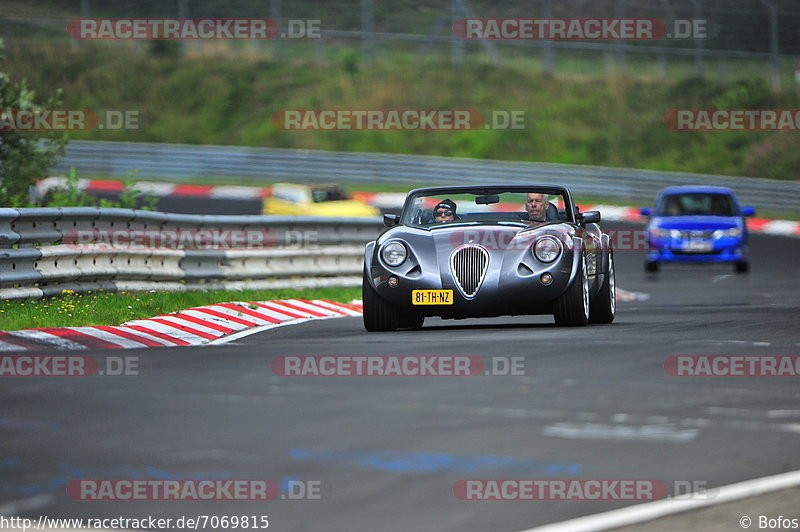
[640,186,756,273]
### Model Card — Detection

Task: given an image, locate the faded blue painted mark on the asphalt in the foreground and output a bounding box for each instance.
[289,448,582,475]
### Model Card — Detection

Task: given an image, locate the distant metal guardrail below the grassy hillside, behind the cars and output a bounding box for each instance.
[54,141,800,211]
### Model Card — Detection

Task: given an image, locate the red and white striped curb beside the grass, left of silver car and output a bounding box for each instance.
[0,299,362,351]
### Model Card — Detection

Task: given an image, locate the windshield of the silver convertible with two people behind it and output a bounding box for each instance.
[402,189,569,227]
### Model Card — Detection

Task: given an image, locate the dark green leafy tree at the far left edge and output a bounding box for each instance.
[0,39,67,207]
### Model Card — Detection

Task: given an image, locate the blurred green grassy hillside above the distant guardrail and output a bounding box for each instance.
[3,43,800,179]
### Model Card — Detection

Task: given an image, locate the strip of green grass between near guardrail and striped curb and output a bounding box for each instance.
[0,288,361,331]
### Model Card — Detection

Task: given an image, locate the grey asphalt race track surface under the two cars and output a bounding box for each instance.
[0,224,800,531]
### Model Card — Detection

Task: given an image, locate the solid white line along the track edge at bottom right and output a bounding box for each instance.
[522,471,800,532]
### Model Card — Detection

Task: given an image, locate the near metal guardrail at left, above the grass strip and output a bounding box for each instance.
[0,207,383,299]
